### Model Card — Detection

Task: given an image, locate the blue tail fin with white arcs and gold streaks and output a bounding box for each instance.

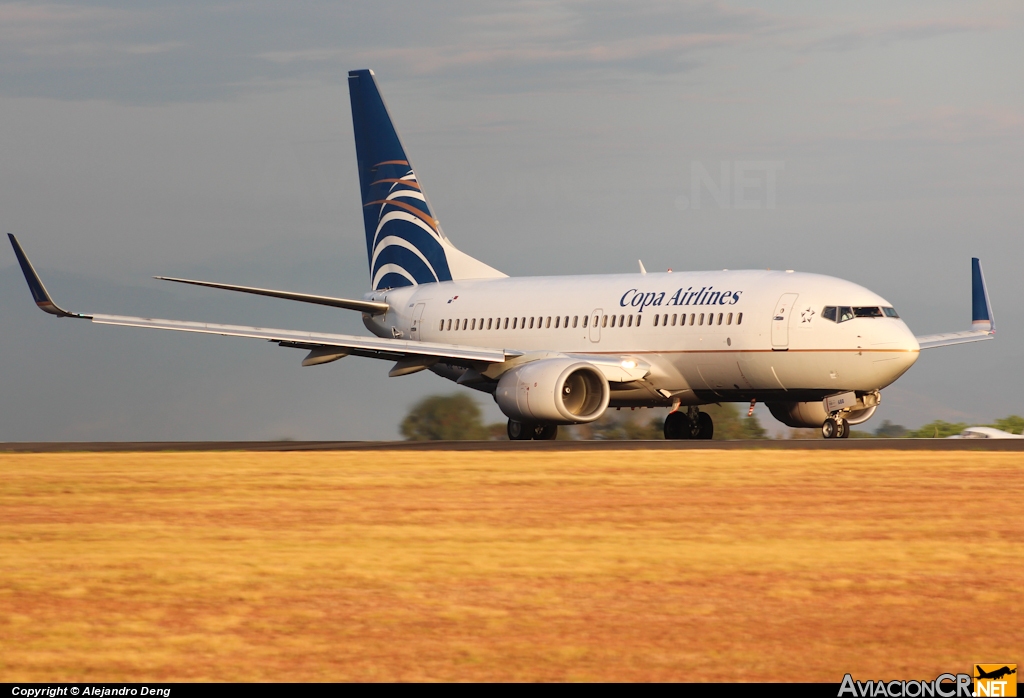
[348,71,505,291]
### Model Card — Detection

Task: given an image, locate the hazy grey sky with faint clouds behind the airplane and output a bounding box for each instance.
[0,0,1024,441]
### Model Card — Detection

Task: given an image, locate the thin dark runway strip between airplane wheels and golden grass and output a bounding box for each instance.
[0,439,1024,453]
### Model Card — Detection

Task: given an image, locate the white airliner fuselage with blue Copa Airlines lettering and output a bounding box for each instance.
[365,270,920,406]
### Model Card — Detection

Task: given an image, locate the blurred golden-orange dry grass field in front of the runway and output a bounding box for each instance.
[0,451,1024,682]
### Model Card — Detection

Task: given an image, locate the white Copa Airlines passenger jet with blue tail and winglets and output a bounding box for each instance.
[9,70,995,440]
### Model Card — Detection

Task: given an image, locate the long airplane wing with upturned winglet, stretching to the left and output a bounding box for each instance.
[7,233,522,376]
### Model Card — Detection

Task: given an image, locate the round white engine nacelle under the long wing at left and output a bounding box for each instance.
[495,358,611,424]
